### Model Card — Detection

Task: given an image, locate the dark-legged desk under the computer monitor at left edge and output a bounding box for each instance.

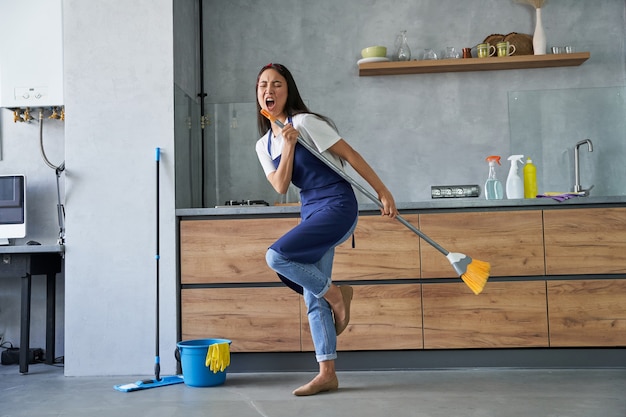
[0,245,65,374]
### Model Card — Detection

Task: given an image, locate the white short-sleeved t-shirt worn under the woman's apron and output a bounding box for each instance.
[256,113,343,176]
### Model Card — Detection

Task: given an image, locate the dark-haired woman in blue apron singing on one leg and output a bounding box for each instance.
[256,64,398,396]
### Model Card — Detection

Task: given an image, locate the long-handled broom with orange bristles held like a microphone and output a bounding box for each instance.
[261,109,491,295]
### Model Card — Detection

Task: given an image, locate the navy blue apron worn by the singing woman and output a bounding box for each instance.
[267,117,358,294]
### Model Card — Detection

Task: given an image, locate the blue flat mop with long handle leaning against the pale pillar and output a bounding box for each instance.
[113,148,184,392]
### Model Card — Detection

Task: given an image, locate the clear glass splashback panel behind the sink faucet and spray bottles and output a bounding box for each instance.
[502,87,626,196]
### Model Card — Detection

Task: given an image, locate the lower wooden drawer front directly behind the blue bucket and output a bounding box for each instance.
[181,287,301,352]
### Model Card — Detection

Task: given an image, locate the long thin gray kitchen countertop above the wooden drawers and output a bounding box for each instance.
[176,196,626,217]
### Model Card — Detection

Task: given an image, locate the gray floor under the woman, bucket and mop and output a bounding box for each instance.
[0,364,626,417]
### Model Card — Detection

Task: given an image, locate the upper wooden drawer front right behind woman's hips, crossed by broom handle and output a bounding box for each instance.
[333,214,420,281]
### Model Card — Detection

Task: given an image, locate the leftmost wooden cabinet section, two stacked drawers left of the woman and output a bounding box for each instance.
[180,218,301,352]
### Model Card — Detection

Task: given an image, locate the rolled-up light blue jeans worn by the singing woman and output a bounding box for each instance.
[265,221,357,362]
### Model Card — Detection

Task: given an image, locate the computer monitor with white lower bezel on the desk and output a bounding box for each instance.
[0,175,26,245]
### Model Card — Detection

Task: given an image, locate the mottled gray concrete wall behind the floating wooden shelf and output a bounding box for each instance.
[205,0,626,202]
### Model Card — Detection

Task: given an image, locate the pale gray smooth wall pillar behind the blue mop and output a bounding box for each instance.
[63,0,176,375]
